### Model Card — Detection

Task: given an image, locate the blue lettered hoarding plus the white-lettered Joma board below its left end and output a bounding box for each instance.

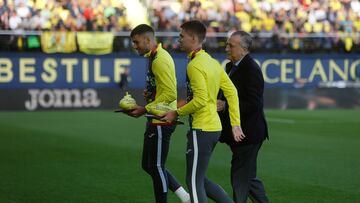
[0,52,360,110]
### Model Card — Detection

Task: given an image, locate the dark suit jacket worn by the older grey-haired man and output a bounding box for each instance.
[219,54,268,146]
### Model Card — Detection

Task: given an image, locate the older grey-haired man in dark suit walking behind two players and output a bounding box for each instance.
[217,31,269,203]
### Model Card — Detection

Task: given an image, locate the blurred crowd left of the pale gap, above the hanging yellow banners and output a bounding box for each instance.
[0,0,130,32]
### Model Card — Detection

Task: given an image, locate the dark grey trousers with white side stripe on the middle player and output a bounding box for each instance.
[186,129,233,203]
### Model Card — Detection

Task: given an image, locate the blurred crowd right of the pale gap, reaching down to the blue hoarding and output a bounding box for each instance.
[148,0,360,52]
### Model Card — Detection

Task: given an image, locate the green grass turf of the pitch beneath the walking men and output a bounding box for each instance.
[0,110,360,203]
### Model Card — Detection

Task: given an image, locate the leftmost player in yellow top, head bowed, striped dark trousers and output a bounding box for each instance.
[128,24,190,203]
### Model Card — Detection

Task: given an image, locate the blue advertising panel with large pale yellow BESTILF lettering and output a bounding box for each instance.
[0,52,360,89]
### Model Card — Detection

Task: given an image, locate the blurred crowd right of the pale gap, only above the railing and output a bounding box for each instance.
[151,0,360,33]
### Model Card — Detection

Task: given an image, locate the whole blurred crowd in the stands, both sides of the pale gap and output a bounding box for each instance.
[0,0,360,53]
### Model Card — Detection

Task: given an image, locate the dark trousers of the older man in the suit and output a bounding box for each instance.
[231,142,269,203]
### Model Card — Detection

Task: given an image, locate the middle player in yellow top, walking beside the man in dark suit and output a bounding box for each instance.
[163,21,245,203]
